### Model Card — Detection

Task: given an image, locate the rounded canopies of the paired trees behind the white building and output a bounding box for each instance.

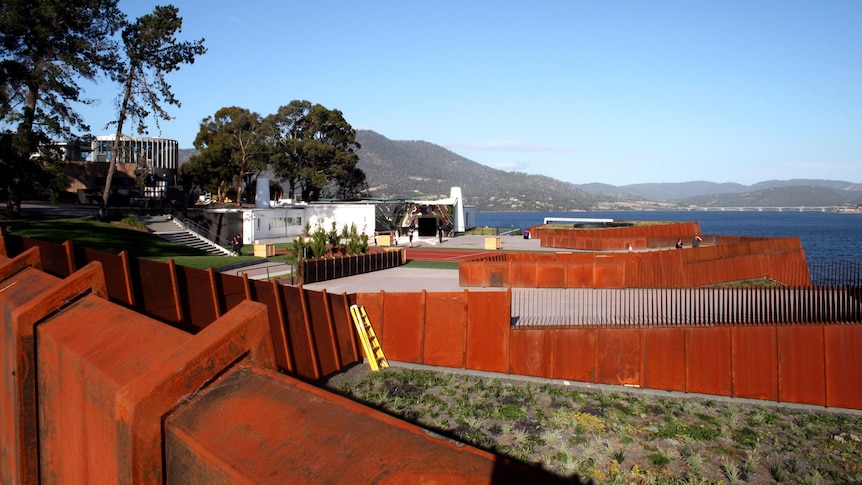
[181,101,366,202]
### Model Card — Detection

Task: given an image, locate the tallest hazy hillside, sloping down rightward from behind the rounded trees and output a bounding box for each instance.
[356,130,640,211]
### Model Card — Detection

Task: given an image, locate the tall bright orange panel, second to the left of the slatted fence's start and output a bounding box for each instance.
[423,291,467,368]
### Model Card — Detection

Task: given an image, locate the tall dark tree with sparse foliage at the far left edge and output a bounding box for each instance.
[0,0,123,206]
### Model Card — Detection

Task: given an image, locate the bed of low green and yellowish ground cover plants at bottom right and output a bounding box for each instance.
[326,366,862,484]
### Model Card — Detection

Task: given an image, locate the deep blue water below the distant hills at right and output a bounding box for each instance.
[476,211,862,262]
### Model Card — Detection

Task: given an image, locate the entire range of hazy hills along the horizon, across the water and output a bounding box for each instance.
[179,130,862,212]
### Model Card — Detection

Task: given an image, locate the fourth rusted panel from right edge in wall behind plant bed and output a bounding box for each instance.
[685,327,733,396]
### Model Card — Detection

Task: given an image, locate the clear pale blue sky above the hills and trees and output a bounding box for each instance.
[80,0,862,185]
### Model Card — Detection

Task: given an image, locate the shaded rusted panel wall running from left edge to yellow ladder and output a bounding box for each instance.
[2,234,362,380]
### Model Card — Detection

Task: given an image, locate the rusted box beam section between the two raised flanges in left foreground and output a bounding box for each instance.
[37,297,192,483]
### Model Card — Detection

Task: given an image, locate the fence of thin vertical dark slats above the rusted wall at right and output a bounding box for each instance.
[511,287,862,327]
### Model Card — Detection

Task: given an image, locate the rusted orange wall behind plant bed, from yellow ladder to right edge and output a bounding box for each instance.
[354,284,862,409]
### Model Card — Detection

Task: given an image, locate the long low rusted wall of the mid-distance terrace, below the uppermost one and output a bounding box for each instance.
[458,238,811,288]
